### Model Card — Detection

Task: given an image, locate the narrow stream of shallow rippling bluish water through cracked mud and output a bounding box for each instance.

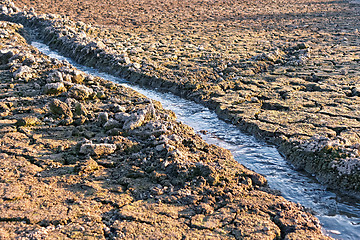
[32,42,360,240]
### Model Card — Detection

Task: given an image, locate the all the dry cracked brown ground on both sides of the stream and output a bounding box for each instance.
[0,0,360,239]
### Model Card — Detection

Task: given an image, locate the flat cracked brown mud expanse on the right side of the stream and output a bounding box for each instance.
[5,0,360,196]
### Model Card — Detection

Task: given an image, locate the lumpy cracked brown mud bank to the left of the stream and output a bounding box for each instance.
[0,18,328,239]
